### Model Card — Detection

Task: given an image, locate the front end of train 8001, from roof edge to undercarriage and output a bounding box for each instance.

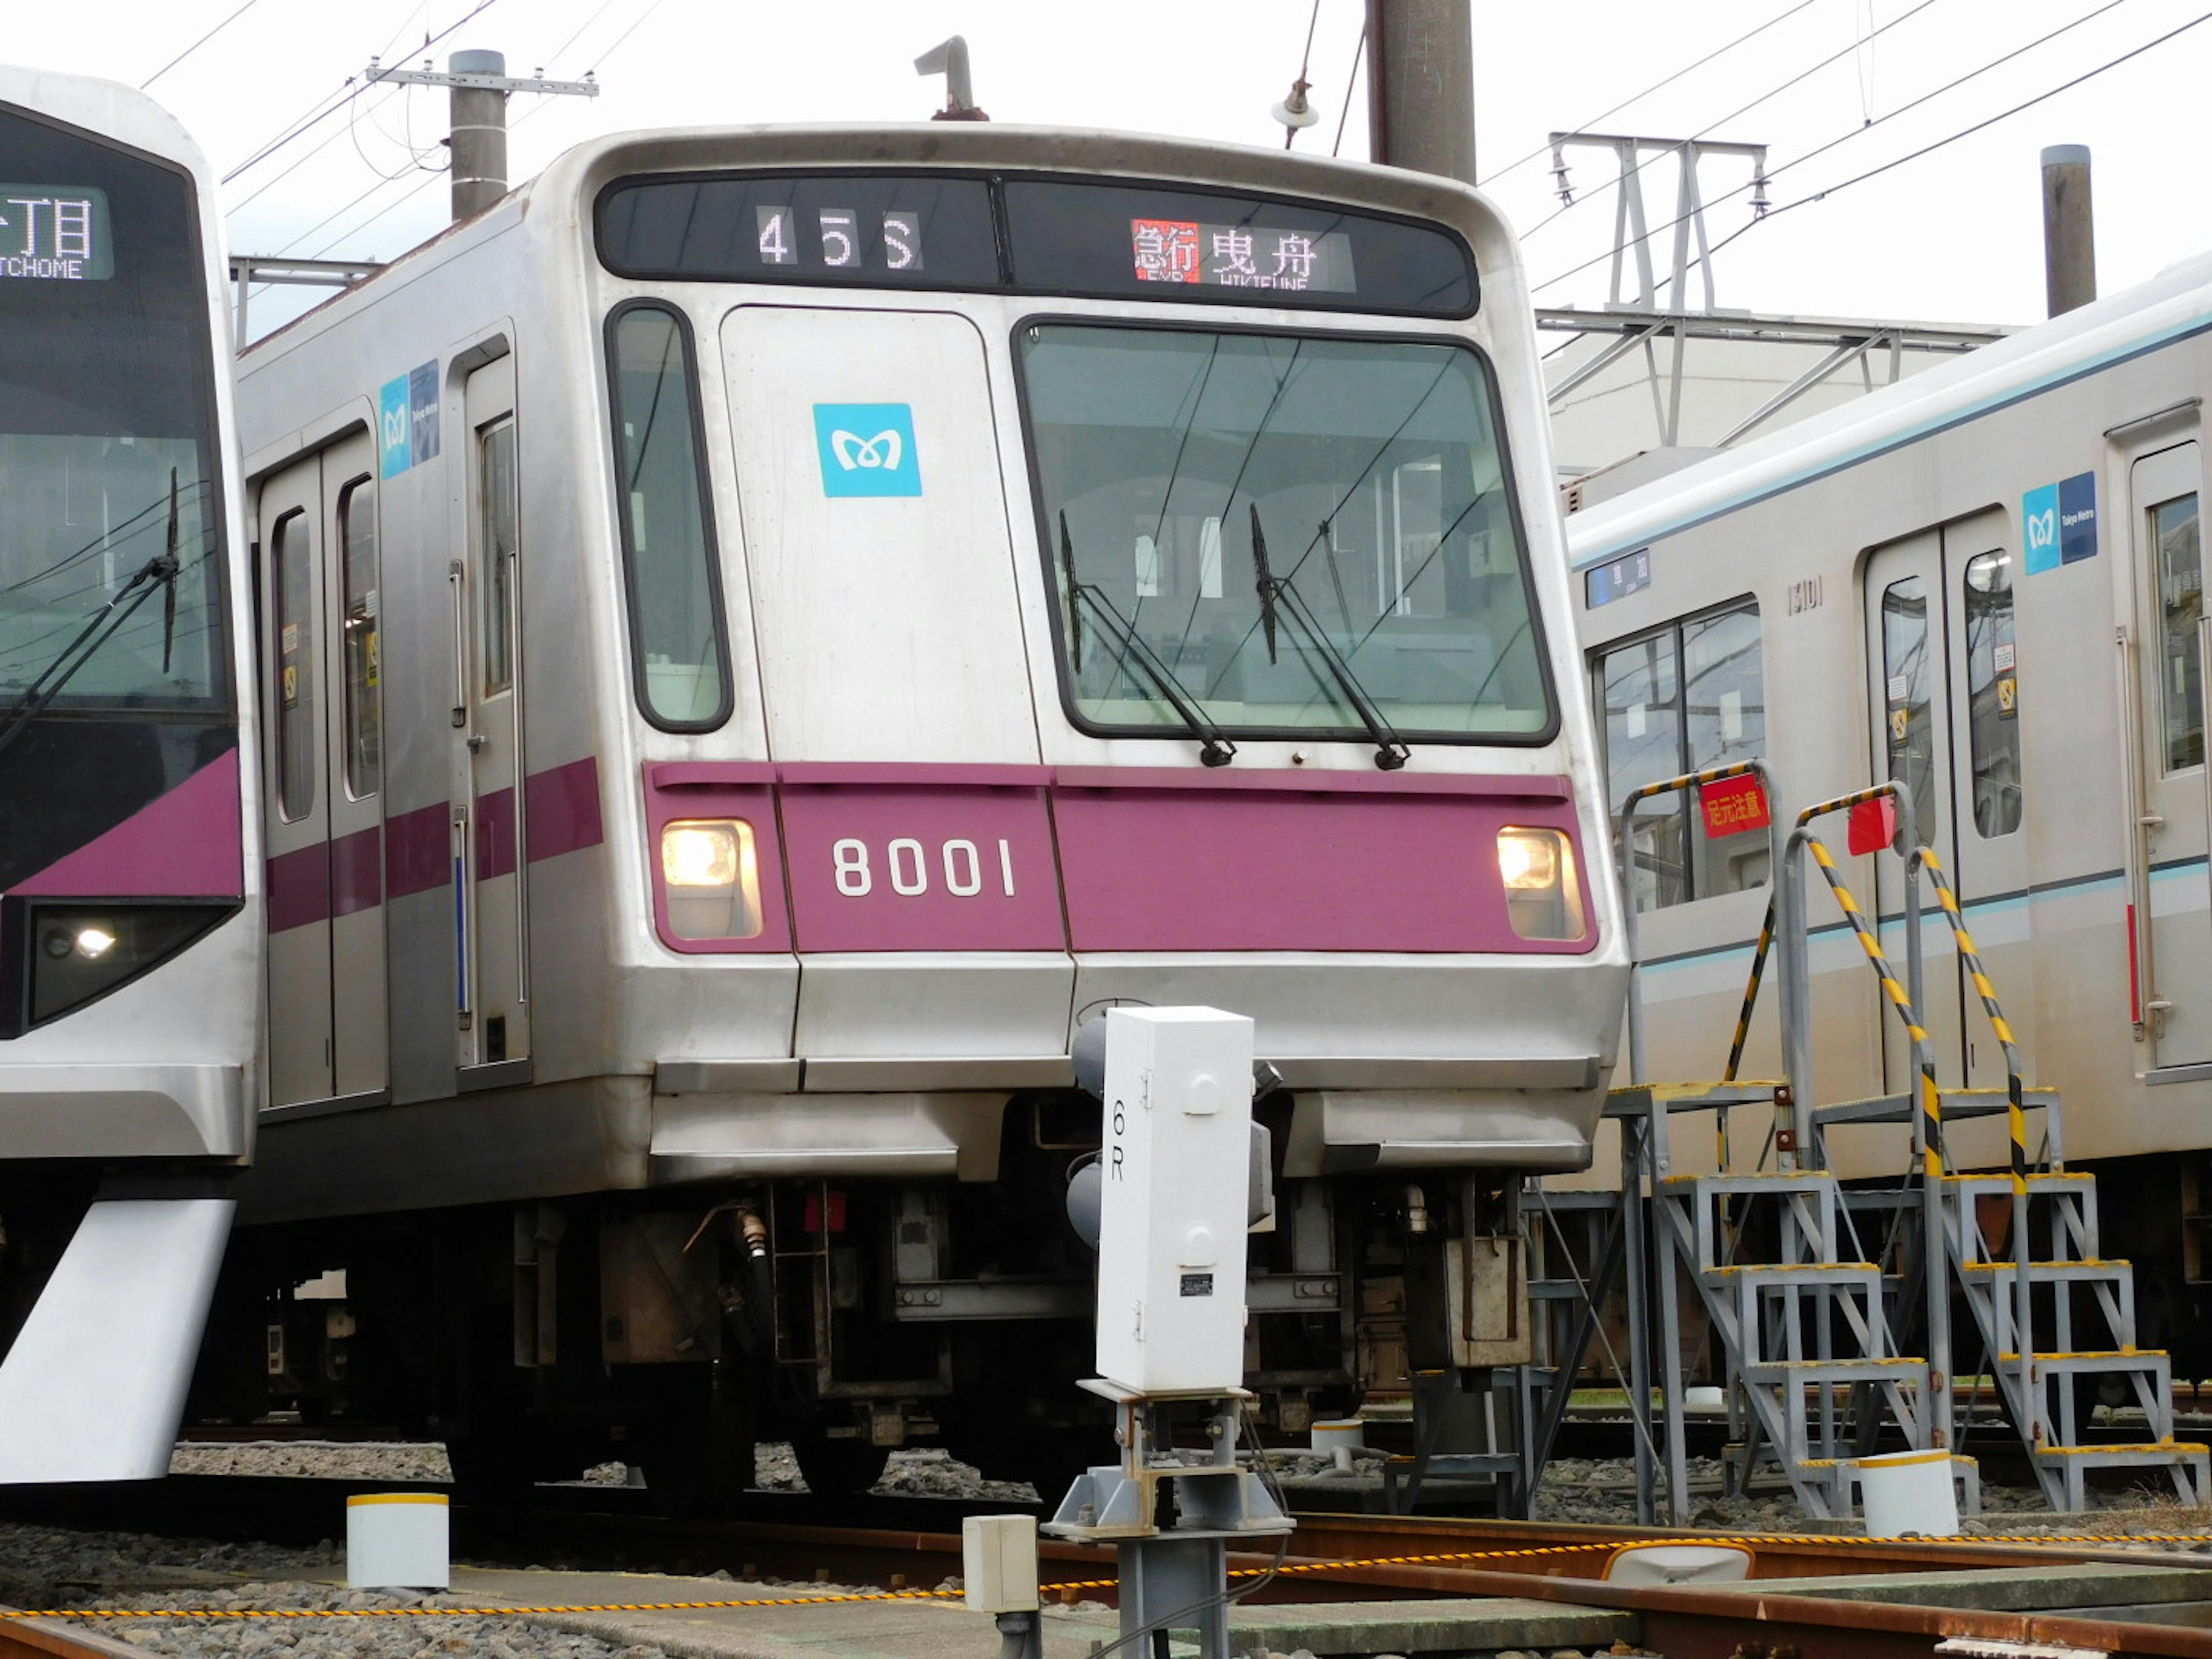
[579,128,1626,1478]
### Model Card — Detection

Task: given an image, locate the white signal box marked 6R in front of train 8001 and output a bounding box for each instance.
[1097,1009,1252,1393]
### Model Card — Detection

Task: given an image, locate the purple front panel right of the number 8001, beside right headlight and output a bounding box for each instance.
[1053,787,1595,953]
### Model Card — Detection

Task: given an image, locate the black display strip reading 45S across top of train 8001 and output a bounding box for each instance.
[597,173,1478,316]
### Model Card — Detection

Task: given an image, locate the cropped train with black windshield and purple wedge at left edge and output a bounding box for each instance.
[0,66,263,1482]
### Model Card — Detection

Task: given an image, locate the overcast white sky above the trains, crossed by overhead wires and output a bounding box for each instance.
[0,0,2212,323]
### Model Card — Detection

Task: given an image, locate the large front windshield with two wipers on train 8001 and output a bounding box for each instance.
[1022,323,1553,741]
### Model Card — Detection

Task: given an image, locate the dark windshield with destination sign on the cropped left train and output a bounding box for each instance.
[0,108,228,732]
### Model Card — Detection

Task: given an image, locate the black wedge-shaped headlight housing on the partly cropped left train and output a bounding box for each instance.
[0,896,239,1037]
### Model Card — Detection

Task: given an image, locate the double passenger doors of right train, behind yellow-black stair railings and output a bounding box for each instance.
[1865,513,2035,1119]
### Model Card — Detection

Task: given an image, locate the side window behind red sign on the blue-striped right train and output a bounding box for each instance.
[1597,604,1772,911]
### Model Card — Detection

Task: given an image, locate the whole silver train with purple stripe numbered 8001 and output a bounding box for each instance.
[226,124,1626,1491]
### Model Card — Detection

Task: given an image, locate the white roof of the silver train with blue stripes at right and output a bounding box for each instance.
[1566,238,2212,569]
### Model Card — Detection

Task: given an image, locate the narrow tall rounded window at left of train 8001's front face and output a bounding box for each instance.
[606,305,730,732]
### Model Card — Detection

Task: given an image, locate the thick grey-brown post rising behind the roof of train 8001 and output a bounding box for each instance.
[1367,0,1475,184]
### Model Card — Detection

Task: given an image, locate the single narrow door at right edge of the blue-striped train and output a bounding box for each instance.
[2128,442,2212,1066]
